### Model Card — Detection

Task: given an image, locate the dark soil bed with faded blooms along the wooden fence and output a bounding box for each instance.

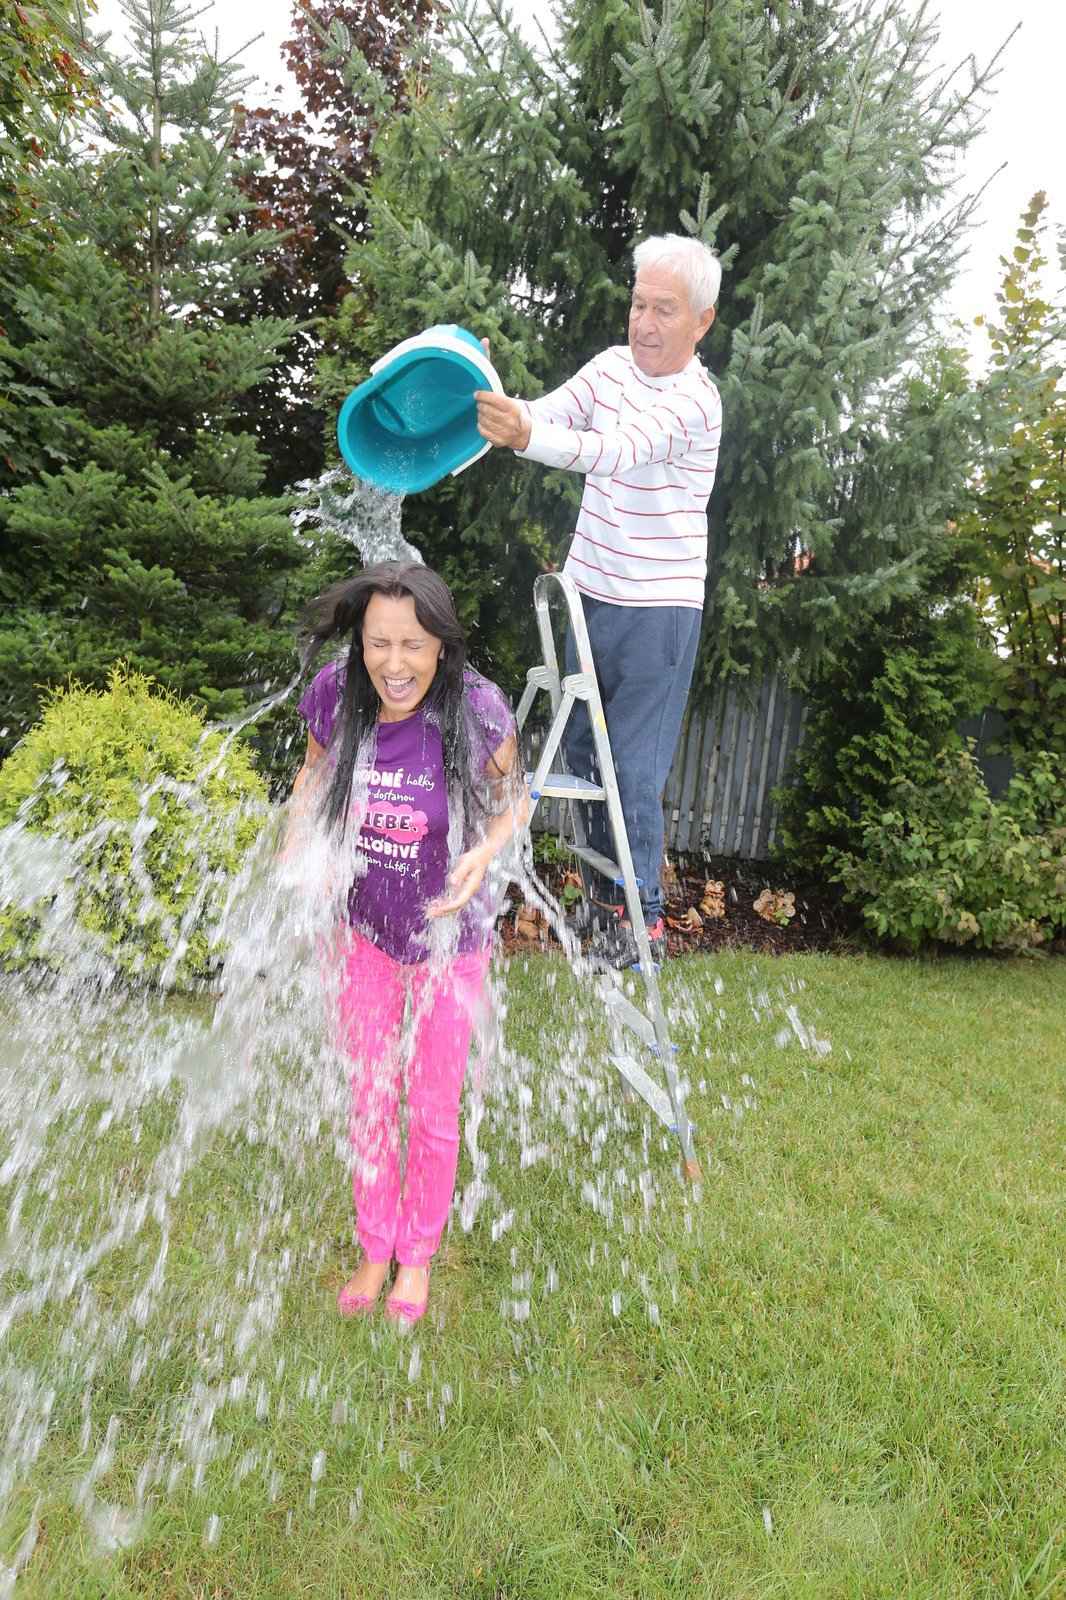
[499,858,861,957]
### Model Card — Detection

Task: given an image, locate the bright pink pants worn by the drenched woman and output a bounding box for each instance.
[332,928,488,1267]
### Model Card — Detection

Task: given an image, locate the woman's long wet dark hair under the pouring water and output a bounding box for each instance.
[301,562,491,829]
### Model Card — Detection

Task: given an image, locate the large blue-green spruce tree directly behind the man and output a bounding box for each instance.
[325,0,986,694]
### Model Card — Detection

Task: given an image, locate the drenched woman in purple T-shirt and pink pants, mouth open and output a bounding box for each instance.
[293,562,525,1323]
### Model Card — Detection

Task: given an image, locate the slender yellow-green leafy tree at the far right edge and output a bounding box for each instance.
[960,194,1066,758]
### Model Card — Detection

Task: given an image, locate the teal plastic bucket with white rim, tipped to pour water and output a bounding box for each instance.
[336,323,504,494]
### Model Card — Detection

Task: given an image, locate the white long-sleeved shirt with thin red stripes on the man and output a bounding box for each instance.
[517,346,722,610]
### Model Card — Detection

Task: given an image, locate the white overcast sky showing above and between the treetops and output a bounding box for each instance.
[96,0,1066,337]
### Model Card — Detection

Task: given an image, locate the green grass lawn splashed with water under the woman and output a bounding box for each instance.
[0,954,1066,1600]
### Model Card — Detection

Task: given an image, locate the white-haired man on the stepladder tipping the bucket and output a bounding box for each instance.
[477,234,722,966]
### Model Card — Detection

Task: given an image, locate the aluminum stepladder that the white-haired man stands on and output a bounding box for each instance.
[517,573,703,1182]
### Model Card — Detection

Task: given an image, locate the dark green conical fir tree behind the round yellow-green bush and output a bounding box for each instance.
[0,0,303,758]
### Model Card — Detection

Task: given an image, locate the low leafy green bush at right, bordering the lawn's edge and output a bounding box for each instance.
[831,747,1066,950]
